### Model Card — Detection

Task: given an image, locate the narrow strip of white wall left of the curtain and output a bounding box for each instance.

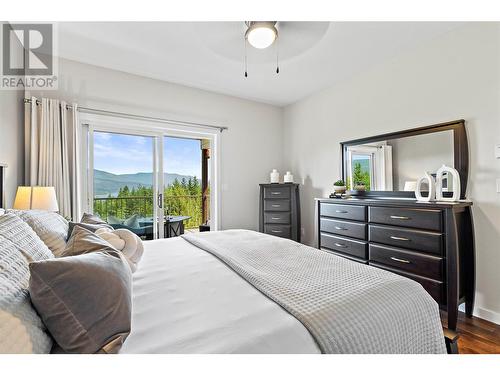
[0,90,24,207]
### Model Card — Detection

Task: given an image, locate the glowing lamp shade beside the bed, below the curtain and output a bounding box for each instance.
[14,186,59,212]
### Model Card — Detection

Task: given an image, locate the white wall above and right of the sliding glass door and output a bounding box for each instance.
[32,59,282,230]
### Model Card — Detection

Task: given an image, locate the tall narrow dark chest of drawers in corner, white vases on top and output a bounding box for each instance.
[259,183,300,242]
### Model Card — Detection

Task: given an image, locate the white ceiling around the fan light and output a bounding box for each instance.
[57,22,462,106]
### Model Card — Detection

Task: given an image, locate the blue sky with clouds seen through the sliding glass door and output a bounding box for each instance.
[94,132,201,178]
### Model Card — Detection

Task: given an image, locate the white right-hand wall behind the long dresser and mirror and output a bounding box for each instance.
[284,23,500,323]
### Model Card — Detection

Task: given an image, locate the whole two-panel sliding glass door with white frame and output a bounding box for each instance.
[83,120,216,244]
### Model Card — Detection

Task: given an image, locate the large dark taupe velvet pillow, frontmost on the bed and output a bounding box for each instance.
[29,250,132,353]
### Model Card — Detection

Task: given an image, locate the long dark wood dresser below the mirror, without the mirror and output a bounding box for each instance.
[316,199,475,330]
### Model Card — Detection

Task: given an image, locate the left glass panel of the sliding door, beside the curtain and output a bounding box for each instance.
[92,131,156,240]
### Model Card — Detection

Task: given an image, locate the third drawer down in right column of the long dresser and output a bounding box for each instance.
[369,244,443,281]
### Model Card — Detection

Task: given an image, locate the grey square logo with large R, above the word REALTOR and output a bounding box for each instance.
[2,23,54,76]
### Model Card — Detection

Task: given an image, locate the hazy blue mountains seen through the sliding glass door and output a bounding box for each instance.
[94,169,192,197]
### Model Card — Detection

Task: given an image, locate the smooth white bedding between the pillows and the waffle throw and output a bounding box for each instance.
[120,237,320,354]
